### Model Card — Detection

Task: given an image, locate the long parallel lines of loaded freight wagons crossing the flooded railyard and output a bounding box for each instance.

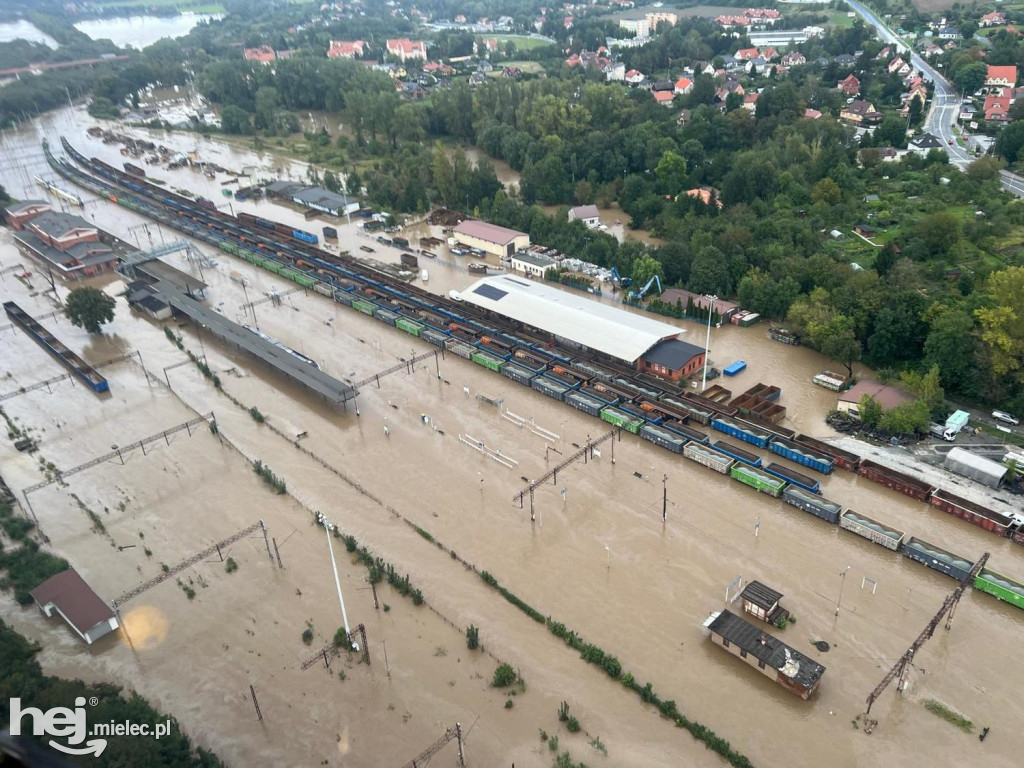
[44,139,1024,607]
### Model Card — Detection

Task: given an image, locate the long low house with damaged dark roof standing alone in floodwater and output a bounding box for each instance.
[703,610,825,700]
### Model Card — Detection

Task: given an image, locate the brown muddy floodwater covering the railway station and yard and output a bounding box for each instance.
[0,113,1024,768]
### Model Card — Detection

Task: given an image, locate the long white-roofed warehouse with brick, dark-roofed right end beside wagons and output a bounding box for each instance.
[461,274,705,381]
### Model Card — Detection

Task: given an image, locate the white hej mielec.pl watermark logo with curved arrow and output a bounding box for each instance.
[10,696,171,758]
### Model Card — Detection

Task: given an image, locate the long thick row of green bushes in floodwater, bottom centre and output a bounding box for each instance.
[480,570,752,768]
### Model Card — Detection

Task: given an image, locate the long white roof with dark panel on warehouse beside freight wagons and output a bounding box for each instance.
[462,274,682,362]
